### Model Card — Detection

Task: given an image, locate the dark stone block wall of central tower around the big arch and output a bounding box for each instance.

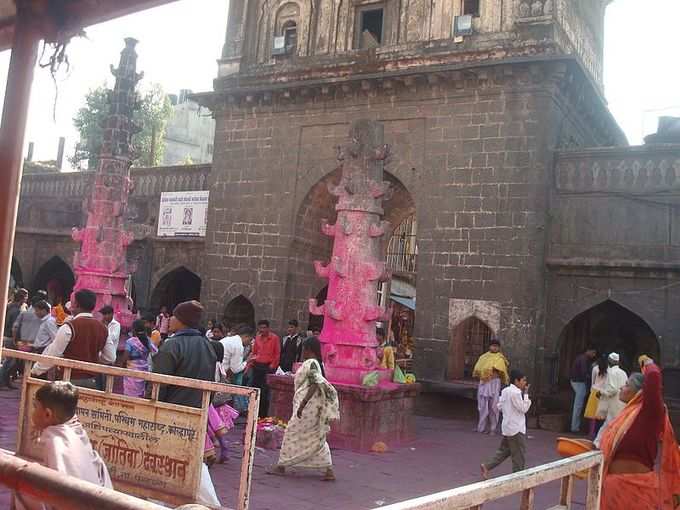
[203,58,624,386]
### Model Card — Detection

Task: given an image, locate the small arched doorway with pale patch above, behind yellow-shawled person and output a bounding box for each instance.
[447,316,493,380]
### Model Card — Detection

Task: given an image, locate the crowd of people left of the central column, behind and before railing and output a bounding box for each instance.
[0,289,339,508]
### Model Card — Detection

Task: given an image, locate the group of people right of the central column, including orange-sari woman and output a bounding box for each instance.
[473,339,680,510]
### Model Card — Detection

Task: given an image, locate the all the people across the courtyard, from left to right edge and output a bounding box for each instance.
[0,289,680,510]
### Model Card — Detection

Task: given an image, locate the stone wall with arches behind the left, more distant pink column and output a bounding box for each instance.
[14,165,210,307]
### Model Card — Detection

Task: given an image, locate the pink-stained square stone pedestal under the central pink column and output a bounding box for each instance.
[267,375,420,451]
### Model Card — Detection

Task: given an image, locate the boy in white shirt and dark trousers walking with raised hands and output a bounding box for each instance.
[481,370,531,480]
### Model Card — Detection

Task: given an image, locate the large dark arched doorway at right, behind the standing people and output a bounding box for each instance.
[558,300,659,388]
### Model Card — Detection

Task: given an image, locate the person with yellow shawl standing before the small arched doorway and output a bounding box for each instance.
[472,338,510,435]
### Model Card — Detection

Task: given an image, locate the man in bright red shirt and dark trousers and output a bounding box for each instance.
[248,320,281,418]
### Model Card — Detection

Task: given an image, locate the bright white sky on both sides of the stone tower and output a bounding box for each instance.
[0,0,680,167]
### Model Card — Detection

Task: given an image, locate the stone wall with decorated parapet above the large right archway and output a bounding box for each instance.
[544,145,680,392]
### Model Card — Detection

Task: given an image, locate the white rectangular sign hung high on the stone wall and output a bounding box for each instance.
[158,191,210,237]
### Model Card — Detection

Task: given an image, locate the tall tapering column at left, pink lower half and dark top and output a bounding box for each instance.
[73,38,142,327]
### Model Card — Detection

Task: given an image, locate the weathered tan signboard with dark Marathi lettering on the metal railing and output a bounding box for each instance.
[19,379,206,503]
